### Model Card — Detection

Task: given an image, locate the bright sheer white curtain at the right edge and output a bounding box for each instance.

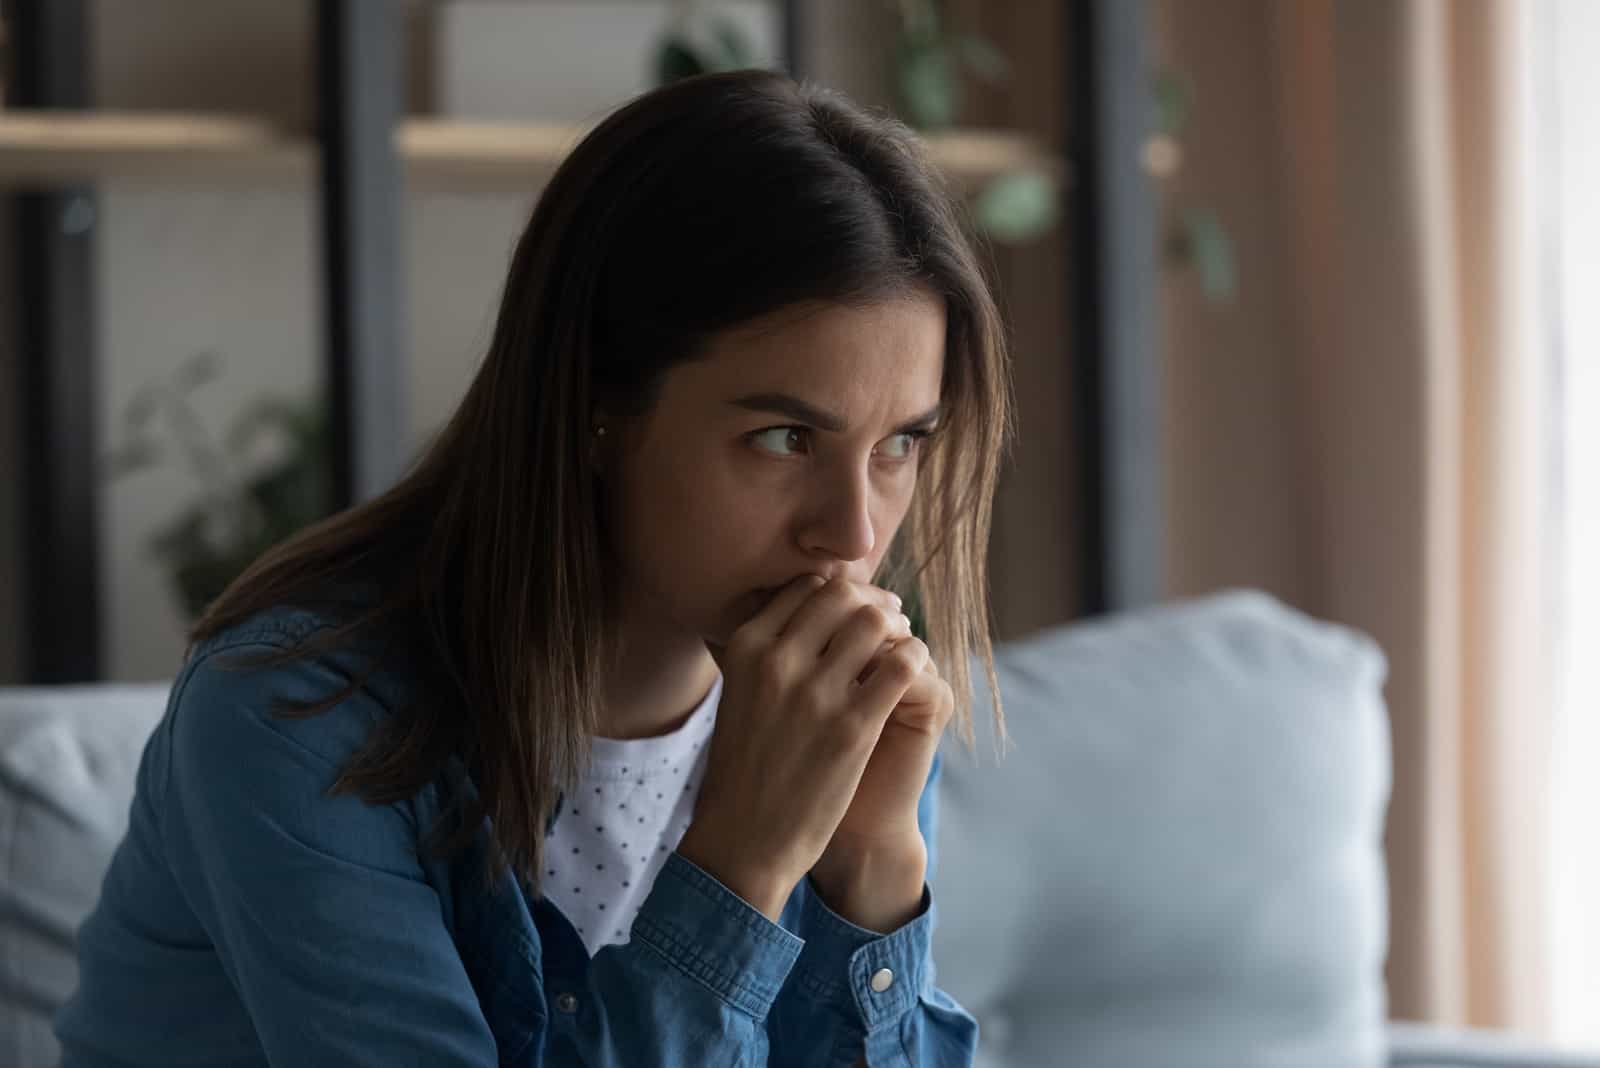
[1536,0,1600,1046]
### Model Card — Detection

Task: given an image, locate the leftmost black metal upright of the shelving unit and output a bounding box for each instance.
[10,0,102,683]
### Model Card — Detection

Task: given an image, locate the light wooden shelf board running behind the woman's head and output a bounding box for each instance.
[0,109,1064,190]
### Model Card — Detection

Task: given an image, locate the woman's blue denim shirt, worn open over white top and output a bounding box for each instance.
[56,609,978,1068]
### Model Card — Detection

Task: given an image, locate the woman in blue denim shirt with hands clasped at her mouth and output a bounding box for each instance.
[65,72,1010,1068]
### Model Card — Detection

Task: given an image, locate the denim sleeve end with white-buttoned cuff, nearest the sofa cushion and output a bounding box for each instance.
[768,753,978,1068]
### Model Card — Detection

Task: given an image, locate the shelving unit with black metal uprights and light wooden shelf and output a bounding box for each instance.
[0,0,1163,683]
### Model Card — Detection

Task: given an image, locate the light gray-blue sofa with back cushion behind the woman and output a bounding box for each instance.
[0,593,1600,1068]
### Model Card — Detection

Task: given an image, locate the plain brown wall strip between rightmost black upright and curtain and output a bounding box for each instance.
[1152,0,1314,608]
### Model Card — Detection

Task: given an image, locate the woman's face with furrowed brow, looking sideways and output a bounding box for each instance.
[598,291,944,644]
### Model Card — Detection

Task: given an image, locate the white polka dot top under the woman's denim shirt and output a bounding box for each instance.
[542,675,722,956]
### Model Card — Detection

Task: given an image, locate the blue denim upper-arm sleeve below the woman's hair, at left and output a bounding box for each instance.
[162,643,498,1068]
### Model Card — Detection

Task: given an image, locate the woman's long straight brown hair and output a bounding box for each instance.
[190,70,1011,889]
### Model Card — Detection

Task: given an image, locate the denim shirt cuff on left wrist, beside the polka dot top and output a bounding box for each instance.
[632,852,805,1020]
